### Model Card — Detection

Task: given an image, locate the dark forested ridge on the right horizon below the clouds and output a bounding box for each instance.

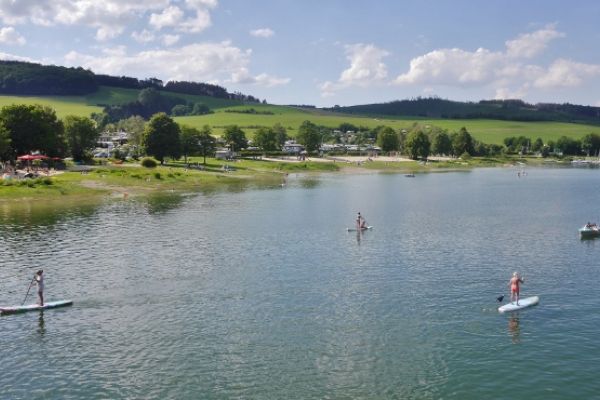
[328,98,600,124]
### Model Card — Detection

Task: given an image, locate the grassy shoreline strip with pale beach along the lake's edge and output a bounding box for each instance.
[0,156,571,205]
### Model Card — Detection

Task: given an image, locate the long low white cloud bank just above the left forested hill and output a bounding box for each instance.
[65,41,289,86]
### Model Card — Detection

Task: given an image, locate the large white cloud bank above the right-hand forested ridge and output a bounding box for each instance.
[394,25,600,98]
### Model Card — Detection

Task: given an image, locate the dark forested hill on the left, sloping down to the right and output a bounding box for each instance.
[0,60,259,102]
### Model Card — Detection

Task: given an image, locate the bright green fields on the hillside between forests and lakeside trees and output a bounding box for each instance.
[0,87,600,144]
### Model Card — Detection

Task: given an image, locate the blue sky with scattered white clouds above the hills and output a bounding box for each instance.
[0,0,600,106]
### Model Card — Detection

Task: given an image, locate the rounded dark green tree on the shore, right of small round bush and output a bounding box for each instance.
[143,113,181,165]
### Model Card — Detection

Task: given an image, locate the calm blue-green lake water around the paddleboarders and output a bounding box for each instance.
[0,168,600,399]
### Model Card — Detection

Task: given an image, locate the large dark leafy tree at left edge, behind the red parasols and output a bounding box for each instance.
[0,104,66,156]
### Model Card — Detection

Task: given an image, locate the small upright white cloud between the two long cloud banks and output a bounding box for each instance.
[320,43,389,97]
